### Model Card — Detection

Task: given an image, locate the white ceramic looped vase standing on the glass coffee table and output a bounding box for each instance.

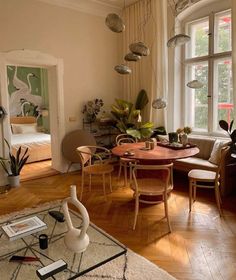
[62,185,89,253]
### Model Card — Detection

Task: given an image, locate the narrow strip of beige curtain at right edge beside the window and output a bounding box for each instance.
[231,0,236,121]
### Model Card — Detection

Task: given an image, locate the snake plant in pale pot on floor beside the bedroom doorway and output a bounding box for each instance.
[0,139,29,187]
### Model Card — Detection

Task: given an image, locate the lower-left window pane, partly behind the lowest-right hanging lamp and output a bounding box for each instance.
[186,62,208,131]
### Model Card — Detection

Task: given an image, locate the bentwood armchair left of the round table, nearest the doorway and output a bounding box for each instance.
[76,146,113,200]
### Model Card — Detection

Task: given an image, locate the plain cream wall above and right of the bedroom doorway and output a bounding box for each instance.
[0,0,121,133]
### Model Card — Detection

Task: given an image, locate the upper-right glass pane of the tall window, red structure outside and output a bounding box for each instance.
[215,11,232,53]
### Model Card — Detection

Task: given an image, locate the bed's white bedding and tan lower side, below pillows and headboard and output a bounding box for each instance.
[11,132,51,163]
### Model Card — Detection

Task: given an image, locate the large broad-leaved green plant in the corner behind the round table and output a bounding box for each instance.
[111,90,153,139]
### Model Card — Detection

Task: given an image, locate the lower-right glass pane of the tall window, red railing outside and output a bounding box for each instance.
[214,58,234,130]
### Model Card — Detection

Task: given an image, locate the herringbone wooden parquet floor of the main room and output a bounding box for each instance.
[0,168,236,280]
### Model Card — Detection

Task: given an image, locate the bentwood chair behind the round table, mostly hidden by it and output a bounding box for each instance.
[116,134,136,186]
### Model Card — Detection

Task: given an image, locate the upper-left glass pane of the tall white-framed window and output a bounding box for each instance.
[186,18,209,58]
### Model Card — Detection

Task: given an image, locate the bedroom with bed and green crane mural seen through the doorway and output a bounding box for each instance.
[7,65,55,179]
